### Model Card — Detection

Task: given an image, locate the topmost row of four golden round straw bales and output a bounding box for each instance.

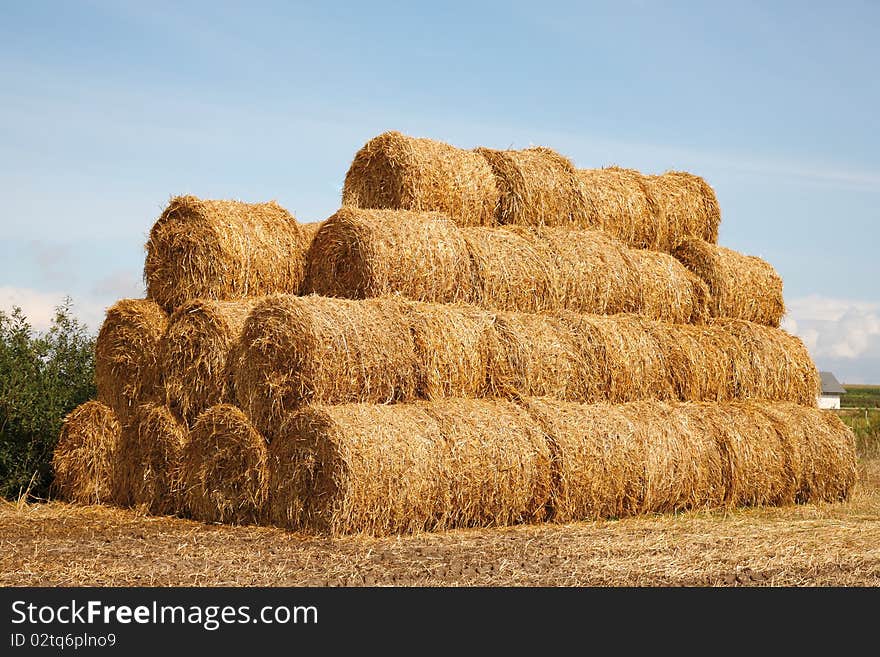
[342,132,721,252]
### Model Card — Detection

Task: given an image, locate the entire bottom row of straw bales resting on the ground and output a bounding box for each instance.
[54,398,856,535]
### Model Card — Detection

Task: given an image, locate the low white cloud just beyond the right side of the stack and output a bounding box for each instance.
[783,295,880,383]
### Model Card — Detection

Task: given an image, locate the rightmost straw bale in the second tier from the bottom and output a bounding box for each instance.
[710,319,820,407]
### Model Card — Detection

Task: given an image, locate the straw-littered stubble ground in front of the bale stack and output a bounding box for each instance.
[0,460,880,586]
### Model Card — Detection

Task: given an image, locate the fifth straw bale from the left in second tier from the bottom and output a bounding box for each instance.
[489,313,594,400]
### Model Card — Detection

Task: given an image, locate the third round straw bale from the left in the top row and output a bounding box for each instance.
[577,167,663,249]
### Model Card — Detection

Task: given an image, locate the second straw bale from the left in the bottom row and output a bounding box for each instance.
[111,403,189,515]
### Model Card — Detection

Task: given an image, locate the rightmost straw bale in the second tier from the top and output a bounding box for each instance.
[673,238,785,327]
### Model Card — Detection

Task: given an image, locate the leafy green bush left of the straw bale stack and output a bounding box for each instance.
[0,299,95,499]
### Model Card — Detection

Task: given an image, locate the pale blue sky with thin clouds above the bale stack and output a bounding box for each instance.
[0,1,880,382]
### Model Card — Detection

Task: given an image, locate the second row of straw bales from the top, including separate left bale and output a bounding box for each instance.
[144,196,784,326]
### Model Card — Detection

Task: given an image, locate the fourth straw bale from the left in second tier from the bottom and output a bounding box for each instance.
[406,303,498,399]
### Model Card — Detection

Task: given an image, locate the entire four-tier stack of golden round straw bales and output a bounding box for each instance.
[54,133,855,534]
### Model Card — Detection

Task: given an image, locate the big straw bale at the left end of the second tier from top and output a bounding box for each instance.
[144,196,308,313]
